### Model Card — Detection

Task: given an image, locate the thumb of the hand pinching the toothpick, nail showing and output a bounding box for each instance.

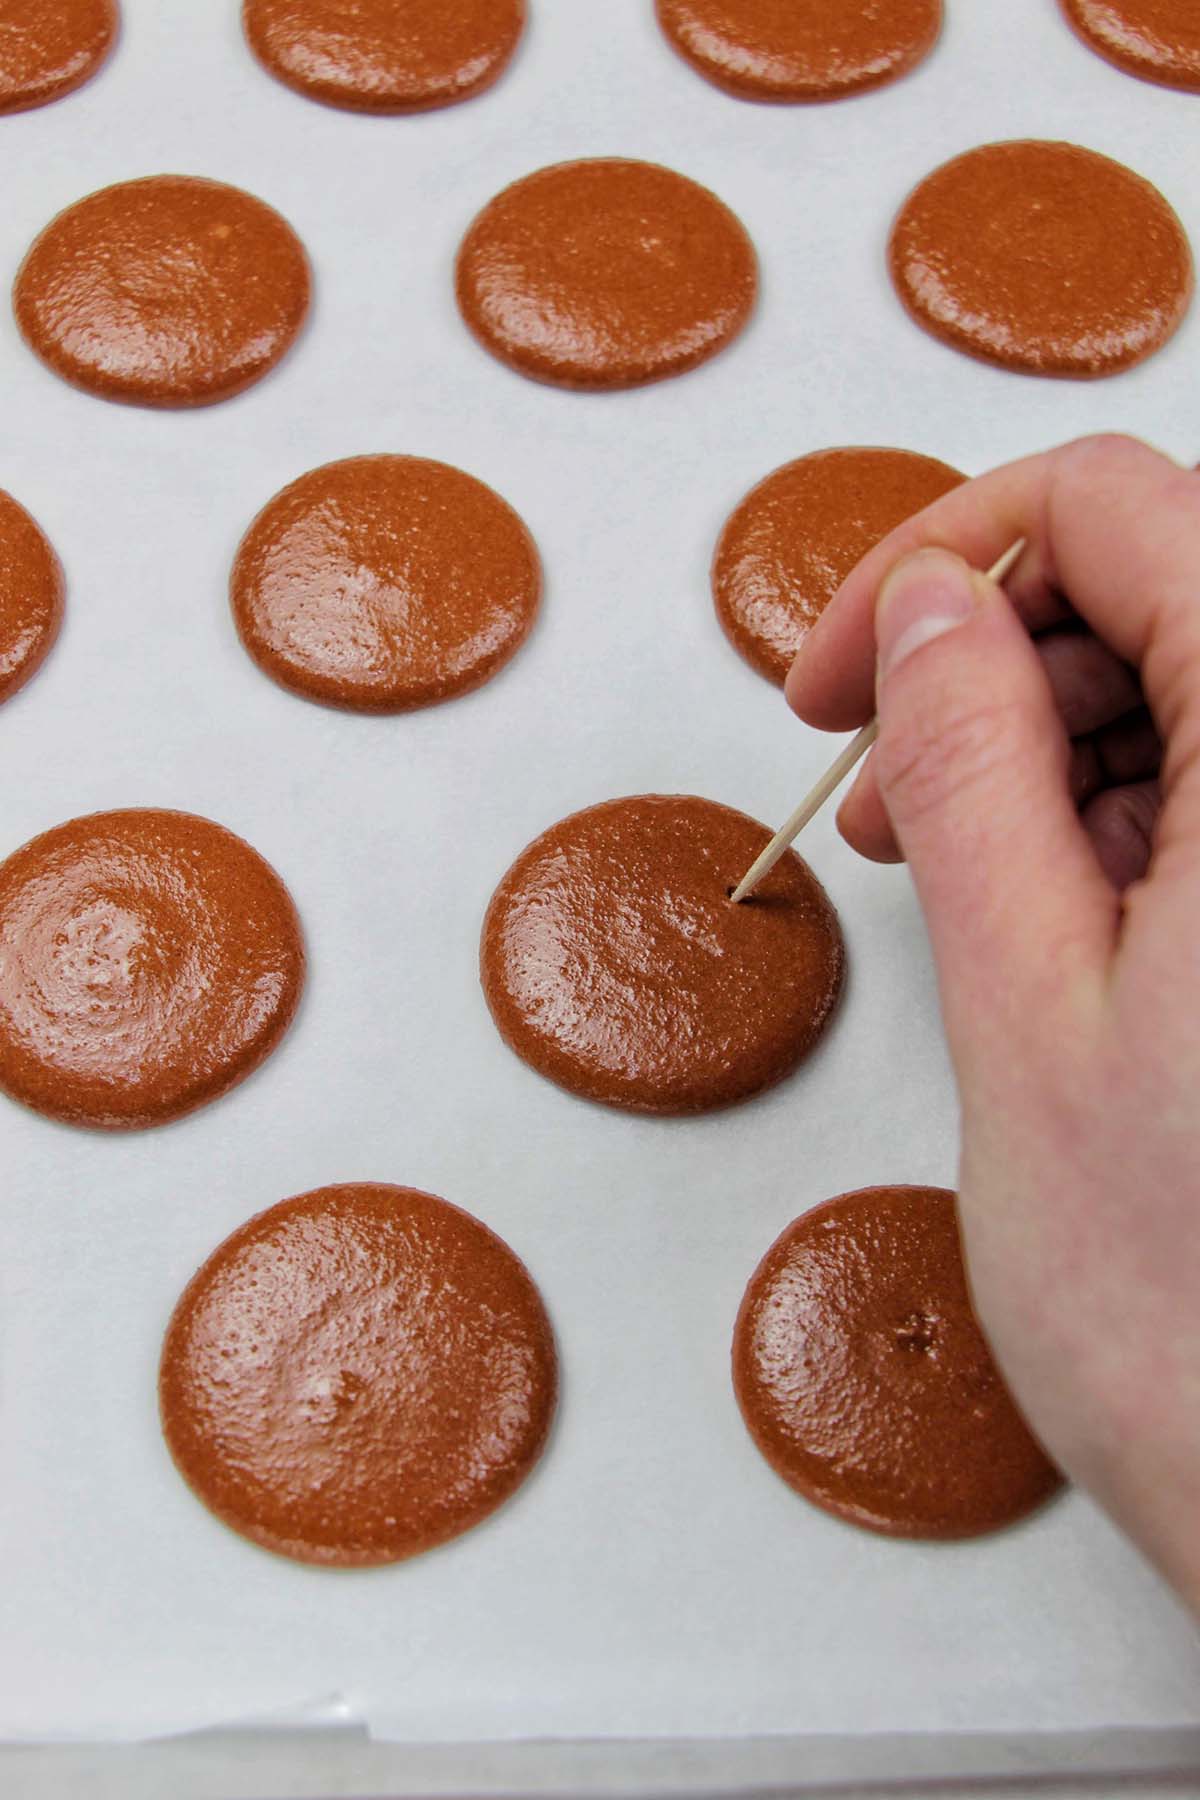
[874,549,1117,1049]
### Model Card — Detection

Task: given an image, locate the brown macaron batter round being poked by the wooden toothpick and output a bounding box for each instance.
[480,794,844,1112]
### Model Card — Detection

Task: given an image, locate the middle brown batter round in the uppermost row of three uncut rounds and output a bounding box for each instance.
[457,157,757,389]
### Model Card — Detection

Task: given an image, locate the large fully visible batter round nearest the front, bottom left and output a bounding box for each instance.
[158,1183,556,1568]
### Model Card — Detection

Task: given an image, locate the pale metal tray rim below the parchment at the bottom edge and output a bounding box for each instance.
[11,1728,1200,1800]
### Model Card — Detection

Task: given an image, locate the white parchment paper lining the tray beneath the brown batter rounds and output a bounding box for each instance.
[0,0,1200,1742]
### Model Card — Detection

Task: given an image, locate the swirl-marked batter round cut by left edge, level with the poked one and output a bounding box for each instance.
[0,808,304,1130]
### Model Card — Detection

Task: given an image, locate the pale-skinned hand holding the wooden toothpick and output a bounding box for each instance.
[788,437,1200,1613]
